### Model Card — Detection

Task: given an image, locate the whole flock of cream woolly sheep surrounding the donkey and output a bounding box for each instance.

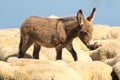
[0,25,120,80]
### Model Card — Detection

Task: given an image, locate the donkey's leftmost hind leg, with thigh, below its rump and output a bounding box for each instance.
[18,38,32,58]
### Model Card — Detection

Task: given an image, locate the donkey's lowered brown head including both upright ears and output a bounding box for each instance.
[77,8,96,48]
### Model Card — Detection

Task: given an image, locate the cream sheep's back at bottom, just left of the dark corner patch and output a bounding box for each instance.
[68,61,112,80]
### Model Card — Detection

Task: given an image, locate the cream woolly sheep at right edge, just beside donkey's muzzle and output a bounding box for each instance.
[87,39,120,61]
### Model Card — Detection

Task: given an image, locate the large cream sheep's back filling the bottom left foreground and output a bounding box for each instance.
[0,59,83,80]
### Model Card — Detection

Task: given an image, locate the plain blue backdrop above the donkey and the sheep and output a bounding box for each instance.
[0,0,120,29]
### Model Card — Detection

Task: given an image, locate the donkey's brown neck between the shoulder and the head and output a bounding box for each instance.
[59,16,81,41]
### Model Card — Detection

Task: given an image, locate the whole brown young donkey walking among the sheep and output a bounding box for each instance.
[18,8,96,61]
